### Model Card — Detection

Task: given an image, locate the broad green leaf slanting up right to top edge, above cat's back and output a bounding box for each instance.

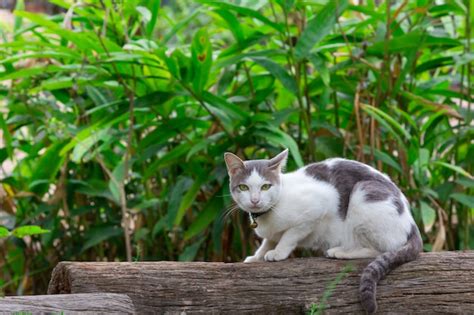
[295,0,349,60]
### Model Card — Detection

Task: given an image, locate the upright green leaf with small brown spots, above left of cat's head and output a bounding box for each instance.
[191,29,212,95]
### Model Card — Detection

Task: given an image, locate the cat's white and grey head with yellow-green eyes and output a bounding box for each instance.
[224,149,288,213]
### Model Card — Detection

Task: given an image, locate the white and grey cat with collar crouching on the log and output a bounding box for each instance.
[224,149,423,313]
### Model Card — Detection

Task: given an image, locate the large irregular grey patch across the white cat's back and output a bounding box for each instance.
[305,160,404,219]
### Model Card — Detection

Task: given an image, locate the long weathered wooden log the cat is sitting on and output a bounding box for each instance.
[48,251,474,314]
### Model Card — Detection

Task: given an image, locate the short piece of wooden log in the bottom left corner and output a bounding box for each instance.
[0,293,135,314]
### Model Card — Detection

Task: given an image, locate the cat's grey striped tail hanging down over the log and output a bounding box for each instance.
[359,225,423,314]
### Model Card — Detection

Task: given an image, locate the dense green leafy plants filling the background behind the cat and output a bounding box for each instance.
[0,0,474,294]
